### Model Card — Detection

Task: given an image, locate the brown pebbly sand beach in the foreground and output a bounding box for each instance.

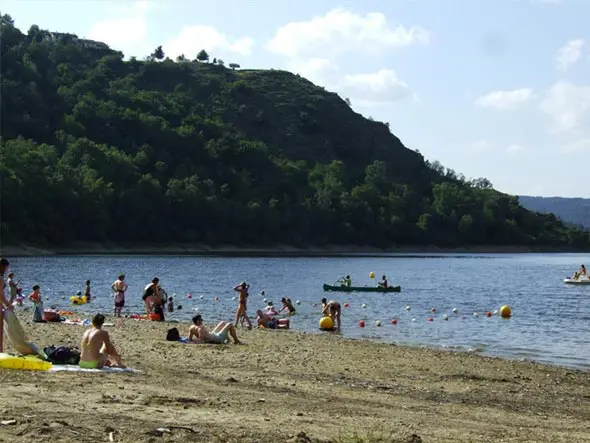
[0,316,590,443]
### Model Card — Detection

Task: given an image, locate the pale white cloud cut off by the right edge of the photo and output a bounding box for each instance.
[540,81,590,132]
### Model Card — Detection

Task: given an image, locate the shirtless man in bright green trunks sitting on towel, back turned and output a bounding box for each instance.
[80,314,125,369]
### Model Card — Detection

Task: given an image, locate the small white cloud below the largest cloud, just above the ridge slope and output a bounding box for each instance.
[338,69,413,104]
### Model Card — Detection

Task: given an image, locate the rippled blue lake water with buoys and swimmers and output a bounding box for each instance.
[5,254,590,369]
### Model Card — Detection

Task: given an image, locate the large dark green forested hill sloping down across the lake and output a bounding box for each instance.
[0,16,590,248]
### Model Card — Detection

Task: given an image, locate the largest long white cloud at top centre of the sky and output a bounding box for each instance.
[267,8,430,59]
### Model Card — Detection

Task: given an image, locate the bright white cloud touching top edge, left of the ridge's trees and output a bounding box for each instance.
[88,1,158,57]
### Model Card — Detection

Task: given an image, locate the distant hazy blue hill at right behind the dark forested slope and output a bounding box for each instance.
[519,195,590,228]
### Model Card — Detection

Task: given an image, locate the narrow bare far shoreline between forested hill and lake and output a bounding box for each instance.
[0,243,587,257]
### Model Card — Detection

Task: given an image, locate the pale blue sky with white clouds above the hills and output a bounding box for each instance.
[0,0,590,197]
